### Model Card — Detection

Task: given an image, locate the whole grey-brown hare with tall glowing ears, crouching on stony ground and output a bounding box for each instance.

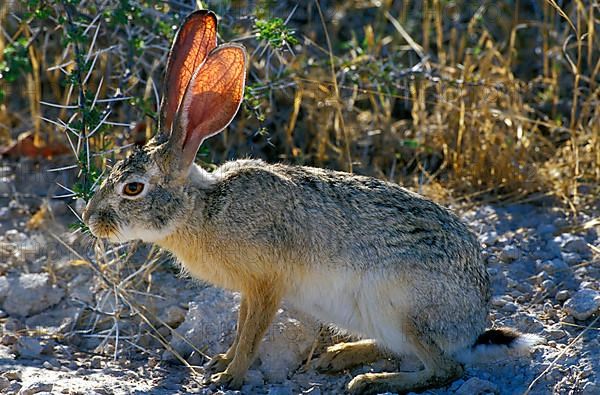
[83,11,539,393]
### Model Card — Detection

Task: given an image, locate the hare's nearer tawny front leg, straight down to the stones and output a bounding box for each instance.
[210,281,282,389]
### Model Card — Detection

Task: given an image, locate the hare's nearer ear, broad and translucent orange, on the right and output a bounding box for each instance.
[171,44,246,170]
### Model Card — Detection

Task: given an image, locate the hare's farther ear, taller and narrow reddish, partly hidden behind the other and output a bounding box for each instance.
[159,10,217,134]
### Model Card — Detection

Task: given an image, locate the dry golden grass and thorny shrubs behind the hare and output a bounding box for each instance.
[0,0,600,207]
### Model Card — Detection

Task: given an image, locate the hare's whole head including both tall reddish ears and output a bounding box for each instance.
[83,11,246,242]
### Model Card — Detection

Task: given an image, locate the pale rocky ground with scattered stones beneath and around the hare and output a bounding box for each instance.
[0,159,600,395]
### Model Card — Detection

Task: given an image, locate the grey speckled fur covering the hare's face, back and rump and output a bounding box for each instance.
[88,145,490,348]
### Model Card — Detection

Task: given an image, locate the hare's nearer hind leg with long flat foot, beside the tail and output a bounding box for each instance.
[348,323,463,394]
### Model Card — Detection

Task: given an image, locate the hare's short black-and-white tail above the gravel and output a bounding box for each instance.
[456,328,545,364]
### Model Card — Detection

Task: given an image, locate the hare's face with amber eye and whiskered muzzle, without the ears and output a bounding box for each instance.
[83,146,190,242]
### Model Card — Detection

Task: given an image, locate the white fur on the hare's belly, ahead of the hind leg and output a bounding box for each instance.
[285,269,410,354]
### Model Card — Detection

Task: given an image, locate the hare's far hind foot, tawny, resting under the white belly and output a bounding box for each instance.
[315,339,383,373]
